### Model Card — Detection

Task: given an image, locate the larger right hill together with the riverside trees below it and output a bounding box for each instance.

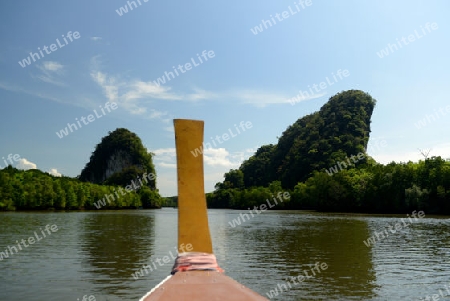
[207,90,450,214]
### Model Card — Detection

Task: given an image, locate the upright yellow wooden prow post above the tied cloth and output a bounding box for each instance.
[174,119,213,254]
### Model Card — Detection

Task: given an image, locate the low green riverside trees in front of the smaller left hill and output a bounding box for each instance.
[0,166,163,210]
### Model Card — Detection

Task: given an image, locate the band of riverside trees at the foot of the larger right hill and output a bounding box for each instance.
[207,157,450,214]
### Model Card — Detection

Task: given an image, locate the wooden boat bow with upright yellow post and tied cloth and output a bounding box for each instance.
[140,119,268,301]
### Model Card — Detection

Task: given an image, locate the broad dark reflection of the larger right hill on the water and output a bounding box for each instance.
[216,212,376,300]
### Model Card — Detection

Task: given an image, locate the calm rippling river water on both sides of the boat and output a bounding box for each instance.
[0,208,450,301]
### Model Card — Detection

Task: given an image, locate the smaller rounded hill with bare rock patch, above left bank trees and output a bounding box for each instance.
[79,129,156,188]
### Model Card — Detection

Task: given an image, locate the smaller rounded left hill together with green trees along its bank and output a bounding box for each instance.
[0,129,164,211]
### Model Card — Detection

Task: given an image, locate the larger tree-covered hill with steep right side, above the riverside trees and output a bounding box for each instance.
[229,90,376,189]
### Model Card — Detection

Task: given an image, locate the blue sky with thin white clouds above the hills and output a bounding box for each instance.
[0,0,450,196]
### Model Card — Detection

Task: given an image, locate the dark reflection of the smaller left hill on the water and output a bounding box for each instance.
[79,211,155,295]
